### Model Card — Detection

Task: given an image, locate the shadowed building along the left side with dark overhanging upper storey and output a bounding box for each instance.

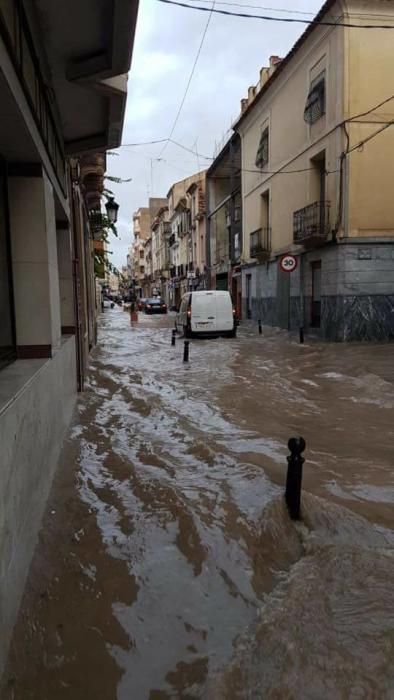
[0,0,138,674]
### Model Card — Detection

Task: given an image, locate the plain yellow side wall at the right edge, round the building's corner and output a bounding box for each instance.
[345,0,394,236]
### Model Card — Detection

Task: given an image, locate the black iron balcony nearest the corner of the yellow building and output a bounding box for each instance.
[293,202,330,248]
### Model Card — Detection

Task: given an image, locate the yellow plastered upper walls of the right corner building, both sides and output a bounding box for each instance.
[238,0,394,262]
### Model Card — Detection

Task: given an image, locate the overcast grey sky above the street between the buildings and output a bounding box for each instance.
[107,0,323,268]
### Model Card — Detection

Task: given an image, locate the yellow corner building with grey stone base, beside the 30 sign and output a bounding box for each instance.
[235,0,394,341]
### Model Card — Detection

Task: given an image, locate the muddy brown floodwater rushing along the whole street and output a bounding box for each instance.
[2,309,394,700]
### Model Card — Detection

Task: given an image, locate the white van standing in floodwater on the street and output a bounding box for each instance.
[175,290,237,338]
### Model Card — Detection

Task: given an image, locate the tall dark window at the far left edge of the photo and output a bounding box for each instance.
[0,162,16,369]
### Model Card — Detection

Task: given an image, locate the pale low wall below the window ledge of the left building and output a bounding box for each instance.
[0,337,76,674]
